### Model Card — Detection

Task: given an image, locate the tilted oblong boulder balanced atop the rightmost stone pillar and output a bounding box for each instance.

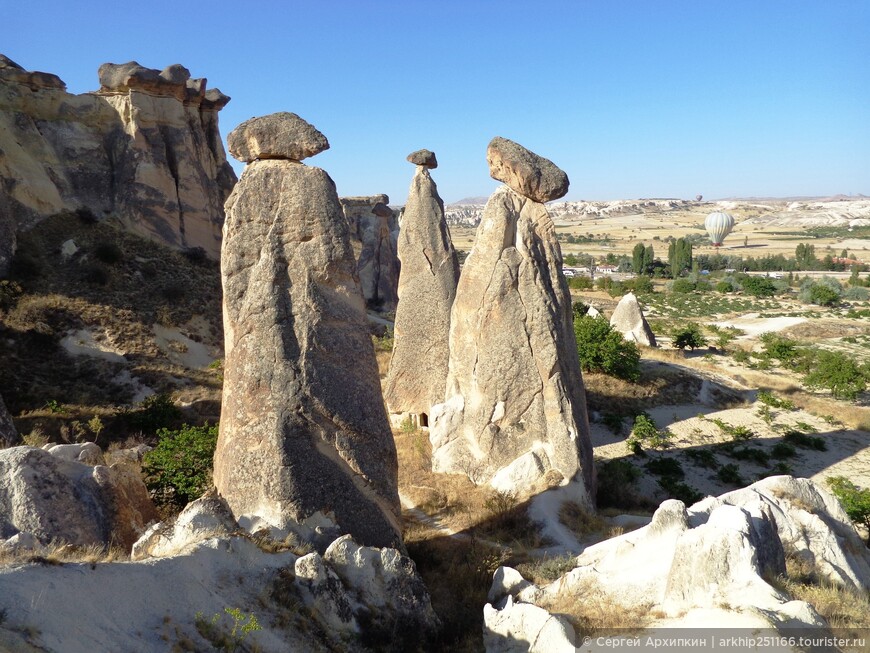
[486,136,568,203]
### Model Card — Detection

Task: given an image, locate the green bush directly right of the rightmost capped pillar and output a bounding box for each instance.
[574,315,640,382]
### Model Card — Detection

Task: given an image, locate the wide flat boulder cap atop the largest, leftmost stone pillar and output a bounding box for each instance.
[227,111,329,163]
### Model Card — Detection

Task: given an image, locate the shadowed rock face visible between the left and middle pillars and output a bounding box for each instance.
[340,195,400,311]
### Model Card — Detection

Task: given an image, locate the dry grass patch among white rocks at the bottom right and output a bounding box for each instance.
[541,579,660,638]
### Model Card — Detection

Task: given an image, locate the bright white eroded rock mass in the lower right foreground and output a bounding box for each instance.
[484,476,870,640]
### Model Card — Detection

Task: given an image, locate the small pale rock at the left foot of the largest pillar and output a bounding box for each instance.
[130,496,239,560]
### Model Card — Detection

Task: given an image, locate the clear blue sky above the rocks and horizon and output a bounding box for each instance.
[0,0,870,204]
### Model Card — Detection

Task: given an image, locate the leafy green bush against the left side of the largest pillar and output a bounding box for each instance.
[142,424,218,510]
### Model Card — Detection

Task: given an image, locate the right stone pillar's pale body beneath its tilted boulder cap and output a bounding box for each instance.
[430,186,594,503]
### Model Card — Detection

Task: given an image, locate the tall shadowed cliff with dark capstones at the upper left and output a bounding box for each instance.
[0,55,236,272]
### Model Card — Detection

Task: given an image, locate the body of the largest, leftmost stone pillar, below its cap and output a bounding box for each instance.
[214,154,401,546]
